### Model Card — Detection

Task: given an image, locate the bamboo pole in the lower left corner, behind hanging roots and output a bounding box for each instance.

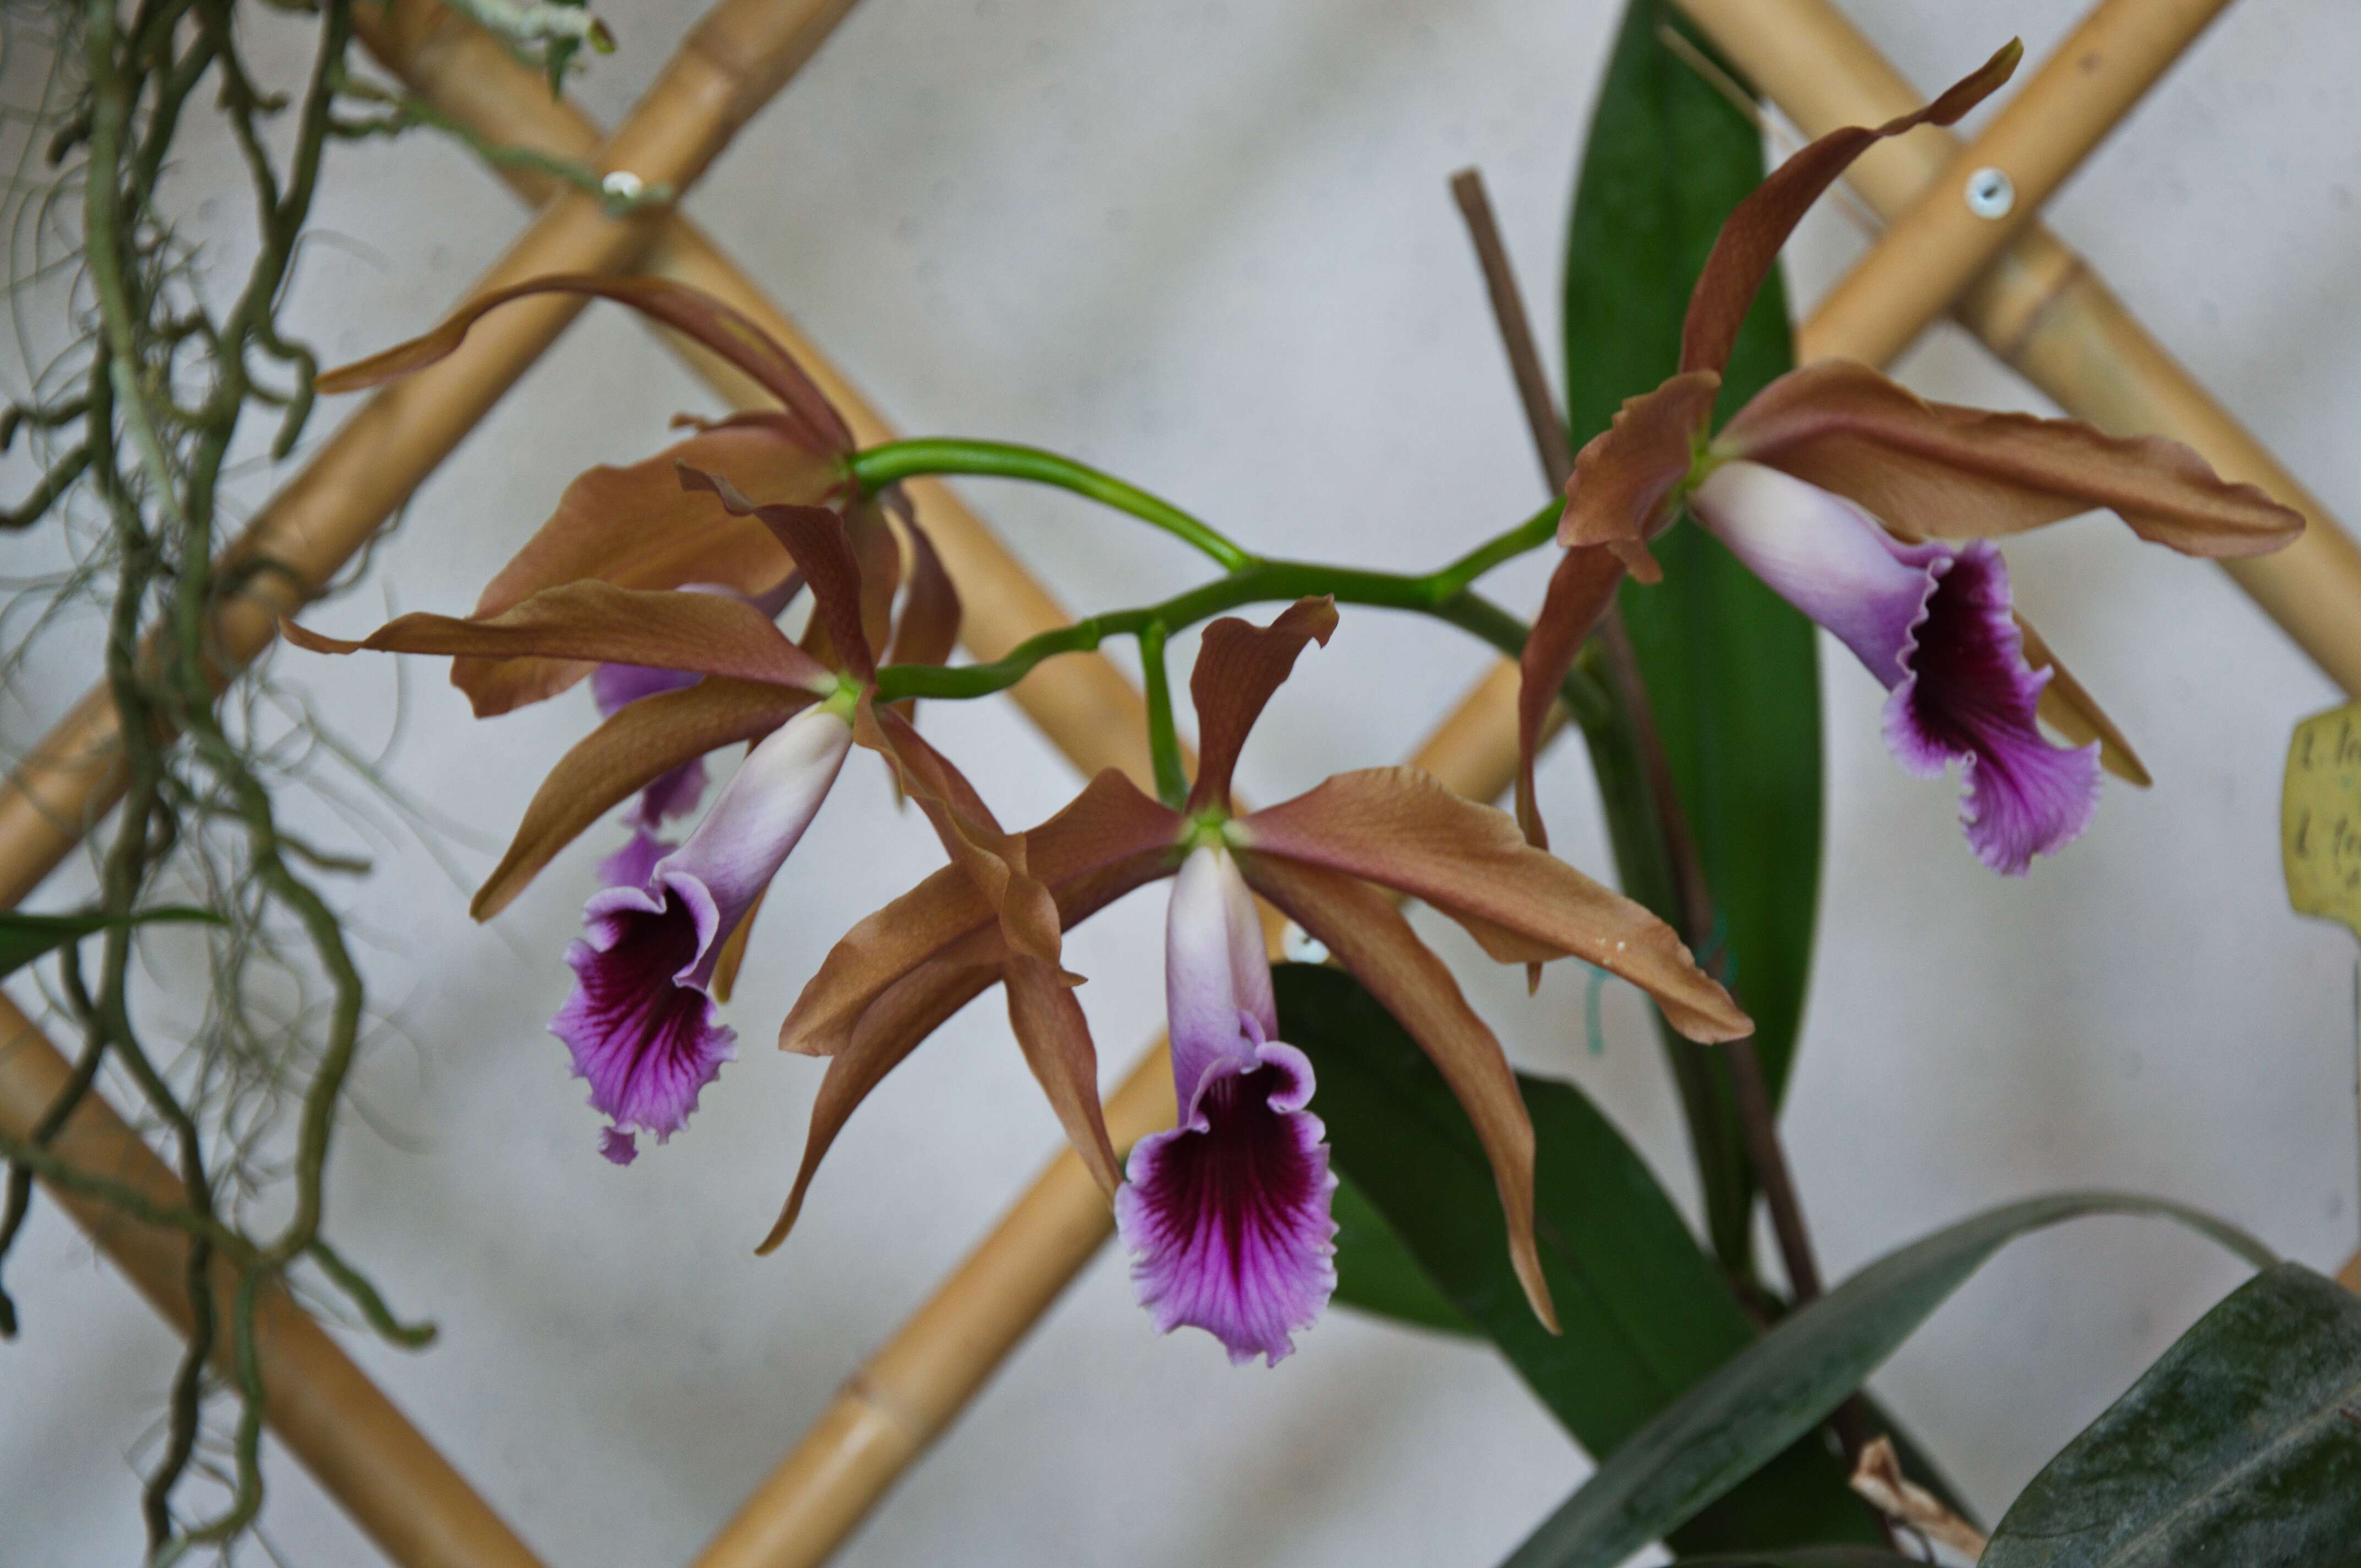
[0,994,541,1568]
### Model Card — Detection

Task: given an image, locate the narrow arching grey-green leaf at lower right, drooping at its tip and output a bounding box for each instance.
[1509,1193,2273,1568]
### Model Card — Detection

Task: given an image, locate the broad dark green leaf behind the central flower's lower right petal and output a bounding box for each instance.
[1272,963,1877,1551]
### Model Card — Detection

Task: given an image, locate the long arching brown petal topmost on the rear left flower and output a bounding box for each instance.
[317,271,855,456]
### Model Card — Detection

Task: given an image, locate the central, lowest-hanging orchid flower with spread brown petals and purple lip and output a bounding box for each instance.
[763,597,1749,1360]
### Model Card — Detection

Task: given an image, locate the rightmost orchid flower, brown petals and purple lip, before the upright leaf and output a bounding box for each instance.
[1518,42,2302,876]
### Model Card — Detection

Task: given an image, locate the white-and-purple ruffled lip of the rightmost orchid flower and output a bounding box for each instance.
[1690,460,2099,876]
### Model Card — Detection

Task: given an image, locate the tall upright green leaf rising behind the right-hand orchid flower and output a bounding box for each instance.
[1565,0,1820,1273]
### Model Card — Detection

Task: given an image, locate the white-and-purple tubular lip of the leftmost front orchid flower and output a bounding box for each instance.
[550,709,852,1164]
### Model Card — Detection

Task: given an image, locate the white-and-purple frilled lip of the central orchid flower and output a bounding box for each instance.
[1114,846,1336,1365]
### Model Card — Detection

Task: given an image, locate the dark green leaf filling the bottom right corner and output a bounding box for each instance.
[1983,1264,2361,1568]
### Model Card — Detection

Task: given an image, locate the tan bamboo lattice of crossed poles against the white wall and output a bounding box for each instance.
[0,0,2361,1568]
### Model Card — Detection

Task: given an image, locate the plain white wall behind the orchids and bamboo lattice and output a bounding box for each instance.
[0,0,2361,1566]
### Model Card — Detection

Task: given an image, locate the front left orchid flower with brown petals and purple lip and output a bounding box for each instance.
[288,477,1001,1164]
